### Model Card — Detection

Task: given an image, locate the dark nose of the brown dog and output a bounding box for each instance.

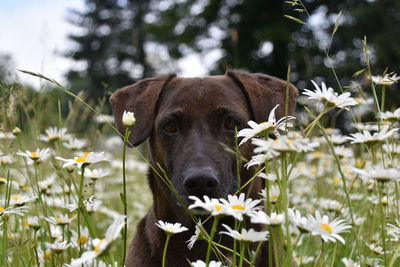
[183,171,219,197]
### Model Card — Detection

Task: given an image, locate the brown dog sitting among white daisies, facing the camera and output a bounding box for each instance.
[111,71,297,267]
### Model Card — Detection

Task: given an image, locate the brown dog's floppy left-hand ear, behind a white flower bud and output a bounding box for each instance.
[110,74,175,146]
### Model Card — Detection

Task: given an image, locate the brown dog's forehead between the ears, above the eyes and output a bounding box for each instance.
[159,76,248,112]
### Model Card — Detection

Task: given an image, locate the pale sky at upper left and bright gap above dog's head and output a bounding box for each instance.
[0,0,206,88]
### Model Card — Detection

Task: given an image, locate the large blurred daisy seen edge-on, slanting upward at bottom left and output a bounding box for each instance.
[70,215,125,267]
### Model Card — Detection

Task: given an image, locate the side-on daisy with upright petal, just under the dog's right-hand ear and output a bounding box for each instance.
[237,104,295,146]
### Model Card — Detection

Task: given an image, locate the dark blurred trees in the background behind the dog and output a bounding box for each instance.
[0,0,400,115]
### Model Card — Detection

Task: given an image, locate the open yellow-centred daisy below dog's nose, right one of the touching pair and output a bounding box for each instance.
[219,193,261,221]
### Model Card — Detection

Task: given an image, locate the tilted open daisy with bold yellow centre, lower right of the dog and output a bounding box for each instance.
[308,210,351,244]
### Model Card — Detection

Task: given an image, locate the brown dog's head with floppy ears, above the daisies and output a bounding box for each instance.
[111,71,297,205]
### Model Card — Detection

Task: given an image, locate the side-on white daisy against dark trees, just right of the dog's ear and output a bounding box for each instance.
[303,80,358,109]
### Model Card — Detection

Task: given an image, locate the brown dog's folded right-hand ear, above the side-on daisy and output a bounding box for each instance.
[226,70,297,123]
